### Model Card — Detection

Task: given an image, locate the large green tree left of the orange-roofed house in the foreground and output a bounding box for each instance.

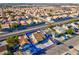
[6,36,19,55]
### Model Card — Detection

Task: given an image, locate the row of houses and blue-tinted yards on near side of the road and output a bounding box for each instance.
[0,21,79,55]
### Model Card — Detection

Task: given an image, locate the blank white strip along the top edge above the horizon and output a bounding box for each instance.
[0,0,79,3]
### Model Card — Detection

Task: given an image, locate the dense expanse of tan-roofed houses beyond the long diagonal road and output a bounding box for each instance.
[0,7,79,31]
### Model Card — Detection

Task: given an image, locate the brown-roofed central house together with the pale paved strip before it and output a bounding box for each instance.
[30,31,54,49]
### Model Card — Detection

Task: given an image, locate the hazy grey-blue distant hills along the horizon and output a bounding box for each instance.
[0,3,79,7]
